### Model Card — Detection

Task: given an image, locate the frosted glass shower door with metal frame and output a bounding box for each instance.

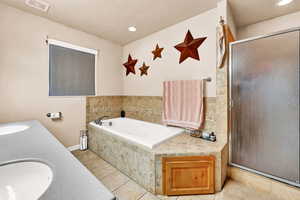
[229,29,300,187]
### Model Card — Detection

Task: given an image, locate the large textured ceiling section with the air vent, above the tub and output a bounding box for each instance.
[0,0,218,45]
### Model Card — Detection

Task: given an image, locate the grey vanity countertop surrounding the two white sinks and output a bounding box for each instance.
[0,121,115,200]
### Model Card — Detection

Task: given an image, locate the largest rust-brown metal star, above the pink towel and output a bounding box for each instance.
[175,30,207,64]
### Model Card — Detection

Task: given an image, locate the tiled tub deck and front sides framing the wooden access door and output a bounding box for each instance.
[88,125,227,194]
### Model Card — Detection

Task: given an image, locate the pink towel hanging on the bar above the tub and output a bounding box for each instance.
[163,80,204,129]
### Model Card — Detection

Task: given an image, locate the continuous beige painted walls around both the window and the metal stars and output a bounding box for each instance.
[0,0,232,146]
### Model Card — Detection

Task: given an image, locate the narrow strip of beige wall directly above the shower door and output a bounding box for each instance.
[238,12,300,40]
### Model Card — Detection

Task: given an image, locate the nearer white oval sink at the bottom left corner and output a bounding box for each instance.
[0,161,53,200]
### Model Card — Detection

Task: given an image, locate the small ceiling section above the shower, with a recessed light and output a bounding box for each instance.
[229,0,300,27]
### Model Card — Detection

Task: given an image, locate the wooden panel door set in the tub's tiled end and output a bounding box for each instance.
[162,156,215,195]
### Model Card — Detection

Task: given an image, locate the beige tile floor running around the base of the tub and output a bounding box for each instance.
[72,150,279,200]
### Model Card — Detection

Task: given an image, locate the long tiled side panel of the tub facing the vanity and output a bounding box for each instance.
[88,124,155,193]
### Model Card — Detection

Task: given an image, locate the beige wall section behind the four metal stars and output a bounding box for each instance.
[122,9,219,97]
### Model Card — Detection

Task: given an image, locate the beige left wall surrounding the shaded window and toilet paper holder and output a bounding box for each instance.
[0,4,122,146]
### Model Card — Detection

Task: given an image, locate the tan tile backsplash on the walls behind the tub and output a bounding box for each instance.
[86,96,216,131]
